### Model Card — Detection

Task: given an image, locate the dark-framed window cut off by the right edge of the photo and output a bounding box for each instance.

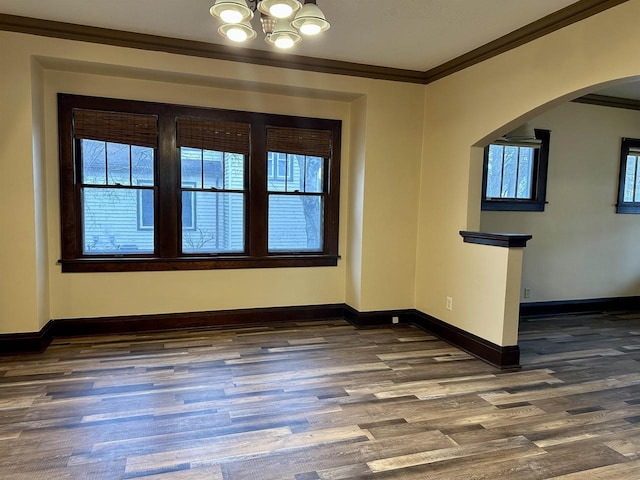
[616,138,640,213]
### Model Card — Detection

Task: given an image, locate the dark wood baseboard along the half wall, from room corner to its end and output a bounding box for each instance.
[400,310,520,369]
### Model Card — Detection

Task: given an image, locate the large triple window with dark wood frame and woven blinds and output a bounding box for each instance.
[58,94,341,272]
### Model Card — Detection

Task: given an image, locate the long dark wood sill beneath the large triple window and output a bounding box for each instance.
[58,254,340,273]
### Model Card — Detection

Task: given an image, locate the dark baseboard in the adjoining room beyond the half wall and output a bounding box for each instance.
[520,297,640,317]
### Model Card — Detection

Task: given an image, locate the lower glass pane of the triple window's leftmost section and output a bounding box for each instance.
[82,187,154,255]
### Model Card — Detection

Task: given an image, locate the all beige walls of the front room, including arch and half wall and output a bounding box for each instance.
[0,0,640,345]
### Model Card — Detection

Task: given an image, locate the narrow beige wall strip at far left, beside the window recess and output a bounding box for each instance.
[0,37,43,332]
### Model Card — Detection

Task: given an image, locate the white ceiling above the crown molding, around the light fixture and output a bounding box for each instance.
[0,0,576,71]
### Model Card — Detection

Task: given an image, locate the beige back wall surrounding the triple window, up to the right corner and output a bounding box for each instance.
[0,28,424,333]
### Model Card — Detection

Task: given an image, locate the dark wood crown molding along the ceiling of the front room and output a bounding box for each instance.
[0,0,629,84]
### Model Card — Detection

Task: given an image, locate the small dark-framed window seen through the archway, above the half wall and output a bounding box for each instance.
[482,129,550,212]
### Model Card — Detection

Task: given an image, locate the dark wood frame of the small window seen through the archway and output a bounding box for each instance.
[482,128,551,212]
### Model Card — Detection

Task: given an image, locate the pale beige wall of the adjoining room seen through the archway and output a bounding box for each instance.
[481,103,640,302]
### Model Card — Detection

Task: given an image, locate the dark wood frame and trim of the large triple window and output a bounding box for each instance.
[58,94,342,272]
